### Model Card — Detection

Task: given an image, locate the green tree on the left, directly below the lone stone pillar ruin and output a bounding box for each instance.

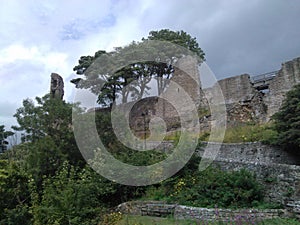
[13,95,85,197]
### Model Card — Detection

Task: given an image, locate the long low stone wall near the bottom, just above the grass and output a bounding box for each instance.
[116,201,289,223]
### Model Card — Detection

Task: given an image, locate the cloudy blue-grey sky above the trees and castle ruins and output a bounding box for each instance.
[0,0,300,129]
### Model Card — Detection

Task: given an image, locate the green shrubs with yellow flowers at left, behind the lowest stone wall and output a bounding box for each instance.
[146,156,263,208]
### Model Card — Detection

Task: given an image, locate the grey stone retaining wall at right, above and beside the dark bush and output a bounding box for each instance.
[197,142,300,205]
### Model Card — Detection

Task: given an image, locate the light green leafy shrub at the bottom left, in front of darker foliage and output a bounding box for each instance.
[33,162,105,225]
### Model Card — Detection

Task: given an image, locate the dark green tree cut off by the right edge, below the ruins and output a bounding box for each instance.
[272,84,300,153]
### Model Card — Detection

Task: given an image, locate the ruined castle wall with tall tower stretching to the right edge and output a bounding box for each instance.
[94,57,300,132]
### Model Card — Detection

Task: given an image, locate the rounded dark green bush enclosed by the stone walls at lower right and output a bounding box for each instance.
[170,167,263,208]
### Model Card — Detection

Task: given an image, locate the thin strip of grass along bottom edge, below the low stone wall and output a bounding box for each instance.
[116,215,300,225]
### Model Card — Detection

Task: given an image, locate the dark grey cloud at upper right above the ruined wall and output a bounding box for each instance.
[204,1,300,77]
